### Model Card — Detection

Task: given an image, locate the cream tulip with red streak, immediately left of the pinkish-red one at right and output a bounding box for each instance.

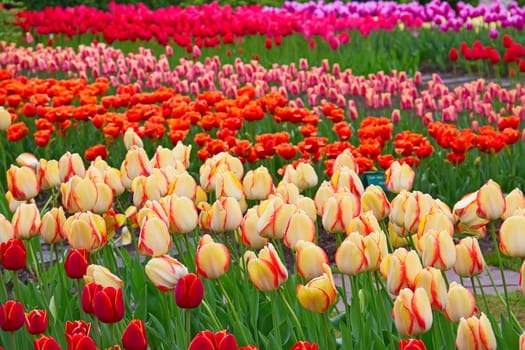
[418,231,456,271]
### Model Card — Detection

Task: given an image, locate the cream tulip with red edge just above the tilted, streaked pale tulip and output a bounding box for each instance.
[138,215,172,257]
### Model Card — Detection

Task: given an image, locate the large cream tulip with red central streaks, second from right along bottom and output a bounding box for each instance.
[392,288,432,337]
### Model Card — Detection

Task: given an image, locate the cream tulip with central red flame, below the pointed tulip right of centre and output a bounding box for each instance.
[322,191,361,233]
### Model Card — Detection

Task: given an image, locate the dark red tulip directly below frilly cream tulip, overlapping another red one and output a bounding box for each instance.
[93,287,124,323]
